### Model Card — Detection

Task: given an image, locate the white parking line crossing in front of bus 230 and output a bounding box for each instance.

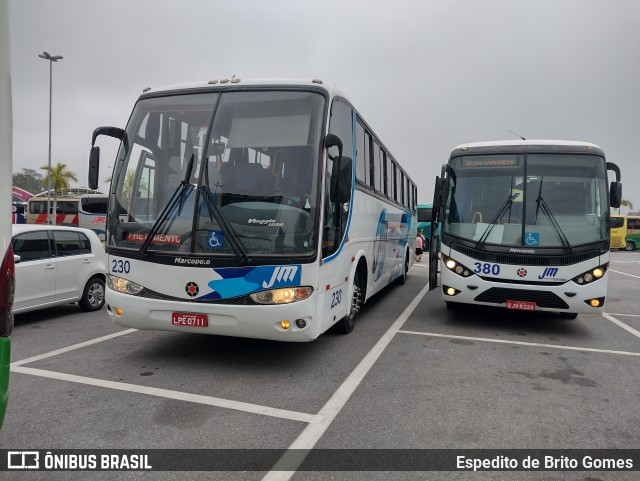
[11,364,317,423]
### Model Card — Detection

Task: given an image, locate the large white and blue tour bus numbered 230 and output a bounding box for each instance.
[89,78,417,341]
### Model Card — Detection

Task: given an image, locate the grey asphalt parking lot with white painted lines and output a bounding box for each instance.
[0,252,640,481]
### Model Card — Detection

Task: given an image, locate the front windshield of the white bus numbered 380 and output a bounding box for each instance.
[443,153,609,249]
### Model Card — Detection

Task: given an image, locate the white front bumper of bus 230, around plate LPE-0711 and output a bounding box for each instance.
[106,288,321,342]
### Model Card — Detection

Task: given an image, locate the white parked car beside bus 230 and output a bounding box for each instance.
[11,224,106,314]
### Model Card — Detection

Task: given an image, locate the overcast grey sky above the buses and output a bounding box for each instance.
[10,0,640,210]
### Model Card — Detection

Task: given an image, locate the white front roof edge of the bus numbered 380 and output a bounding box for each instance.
[451,140,604,157]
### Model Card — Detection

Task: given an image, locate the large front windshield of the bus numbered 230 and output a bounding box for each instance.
[107,90,324,259]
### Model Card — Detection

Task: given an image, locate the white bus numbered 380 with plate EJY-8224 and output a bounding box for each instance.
[429,140,622,318]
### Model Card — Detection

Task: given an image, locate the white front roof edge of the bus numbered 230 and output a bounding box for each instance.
[142,76,344,97]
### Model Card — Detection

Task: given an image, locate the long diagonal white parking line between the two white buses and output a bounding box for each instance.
[262,285,429,481]
